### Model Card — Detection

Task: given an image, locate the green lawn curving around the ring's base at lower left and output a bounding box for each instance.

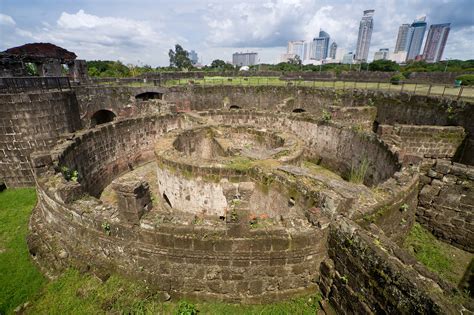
[0,188,321,315]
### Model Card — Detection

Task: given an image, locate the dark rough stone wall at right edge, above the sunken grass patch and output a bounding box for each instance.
[416,160,474,252]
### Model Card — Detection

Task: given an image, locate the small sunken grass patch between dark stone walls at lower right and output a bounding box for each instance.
[405,223,474,285]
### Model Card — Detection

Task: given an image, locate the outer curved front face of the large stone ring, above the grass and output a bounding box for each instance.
[30,178,326,303]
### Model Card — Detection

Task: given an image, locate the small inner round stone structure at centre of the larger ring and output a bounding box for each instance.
[155,125,303,218]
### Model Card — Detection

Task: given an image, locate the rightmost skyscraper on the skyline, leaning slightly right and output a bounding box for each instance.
[423,23,451,62]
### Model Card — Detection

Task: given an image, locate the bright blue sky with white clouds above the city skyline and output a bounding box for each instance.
[0,0,474,67]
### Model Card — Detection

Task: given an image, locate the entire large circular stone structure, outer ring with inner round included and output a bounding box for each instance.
[29,110,417,303]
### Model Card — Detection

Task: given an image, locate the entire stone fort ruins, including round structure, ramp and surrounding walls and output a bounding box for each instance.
[0,44,474,314]
